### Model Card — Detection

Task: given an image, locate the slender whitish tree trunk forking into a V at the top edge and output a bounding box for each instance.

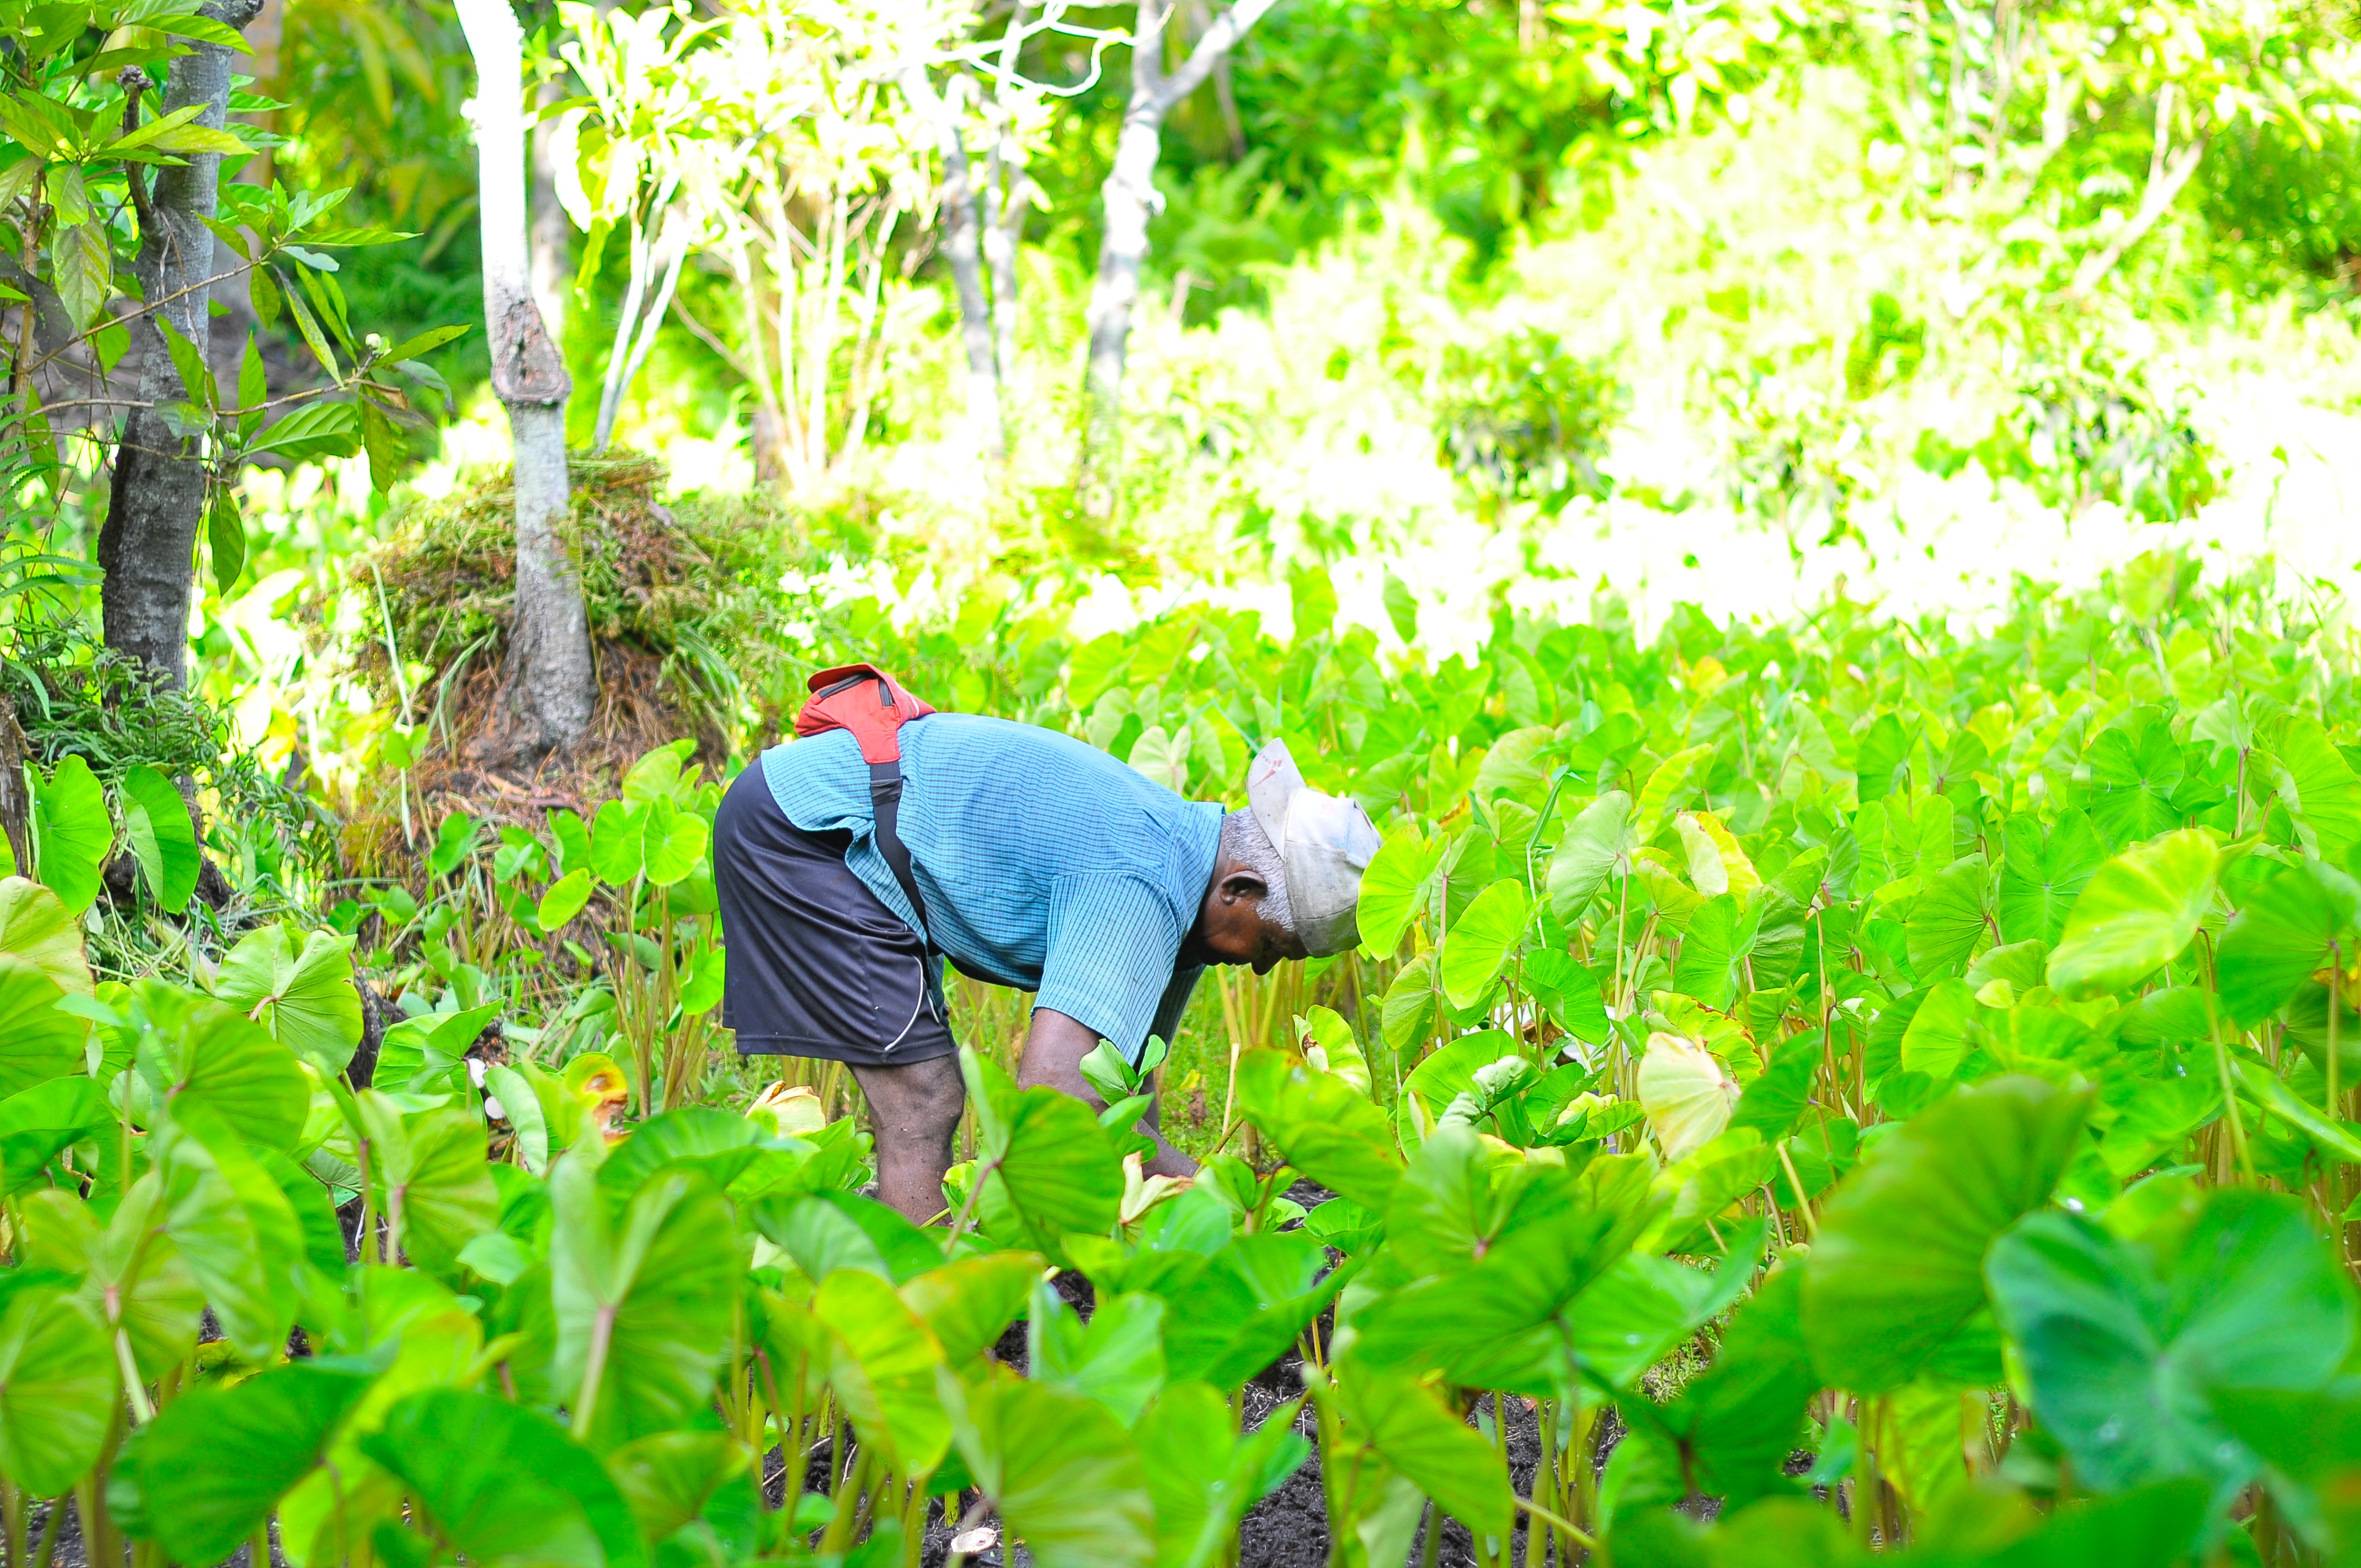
[1074,0,1275,517]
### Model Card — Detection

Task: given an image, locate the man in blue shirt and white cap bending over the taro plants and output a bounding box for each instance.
[713,713,1377,1223]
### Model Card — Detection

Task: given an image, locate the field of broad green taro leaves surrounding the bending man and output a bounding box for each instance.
[14,543,2361,1568]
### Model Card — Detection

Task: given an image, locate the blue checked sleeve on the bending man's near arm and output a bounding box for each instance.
[1034,876,1183,1060]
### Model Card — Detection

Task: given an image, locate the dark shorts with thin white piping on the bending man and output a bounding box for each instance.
[713,763,959,1068]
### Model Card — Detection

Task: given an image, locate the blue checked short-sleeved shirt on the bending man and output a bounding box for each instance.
[763,713,1223,1060]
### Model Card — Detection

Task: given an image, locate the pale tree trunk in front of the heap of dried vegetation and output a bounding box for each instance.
[458,0,597,763]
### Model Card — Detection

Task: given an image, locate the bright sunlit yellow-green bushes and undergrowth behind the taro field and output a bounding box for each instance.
[19,0,2361,831]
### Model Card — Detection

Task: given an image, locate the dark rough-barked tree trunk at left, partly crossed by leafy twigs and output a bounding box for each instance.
[99,0,262,687]
